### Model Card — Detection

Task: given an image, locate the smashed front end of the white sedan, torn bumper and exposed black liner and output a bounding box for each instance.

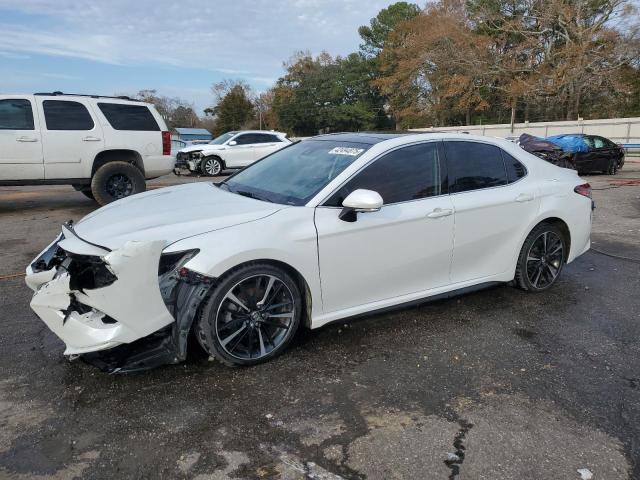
[26,225,213,372]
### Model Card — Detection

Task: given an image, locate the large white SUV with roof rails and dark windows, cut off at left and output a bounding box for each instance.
[0,92,175,205]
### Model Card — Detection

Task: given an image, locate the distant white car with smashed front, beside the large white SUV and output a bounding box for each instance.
[175,130,291,177]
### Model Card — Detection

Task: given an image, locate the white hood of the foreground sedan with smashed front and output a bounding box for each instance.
[74,182,286,250]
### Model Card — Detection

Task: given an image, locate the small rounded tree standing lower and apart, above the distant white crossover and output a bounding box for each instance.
[205,80,254,135]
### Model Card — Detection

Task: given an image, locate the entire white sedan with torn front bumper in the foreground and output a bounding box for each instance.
[26,133,592,371]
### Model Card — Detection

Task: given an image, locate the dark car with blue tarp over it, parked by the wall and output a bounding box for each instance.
[546,134,625,175]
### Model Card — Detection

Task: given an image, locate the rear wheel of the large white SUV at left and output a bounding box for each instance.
[91,162,147,205]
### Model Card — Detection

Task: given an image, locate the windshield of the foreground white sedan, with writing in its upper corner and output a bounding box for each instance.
[220,140,371,205]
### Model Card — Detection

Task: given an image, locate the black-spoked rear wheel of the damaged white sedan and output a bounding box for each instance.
[514,223,568,292]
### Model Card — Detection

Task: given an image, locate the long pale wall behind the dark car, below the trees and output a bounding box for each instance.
[411,117,640,144]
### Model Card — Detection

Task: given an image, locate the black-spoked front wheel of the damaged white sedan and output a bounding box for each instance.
[194,264,303,366]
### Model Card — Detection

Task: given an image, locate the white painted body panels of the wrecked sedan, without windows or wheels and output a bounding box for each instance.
[27,134,591,353]
